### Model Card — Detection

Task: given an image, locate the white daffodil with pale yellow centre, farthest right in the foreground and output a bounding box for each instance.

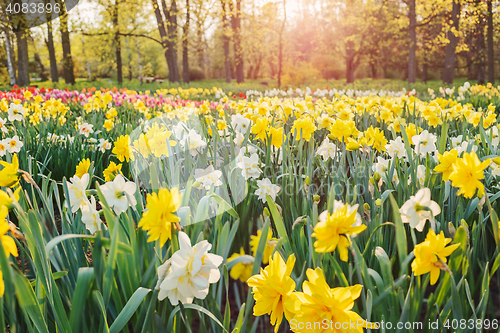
[399,188,441,231]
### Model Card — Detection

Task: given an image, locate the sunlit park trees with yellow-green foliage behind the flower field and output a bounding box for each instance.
[0,0,500,87]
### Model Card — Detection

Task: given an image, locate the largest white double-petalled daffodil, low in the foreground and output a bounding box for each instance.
[157,231,223,306]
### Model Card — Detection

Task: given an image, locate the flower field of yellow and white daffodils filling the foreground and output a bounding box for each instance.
[0,83,500,332]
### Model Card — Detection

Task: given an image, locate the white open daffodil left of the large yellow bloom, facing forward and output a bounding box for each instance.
[99,174,137,215]
